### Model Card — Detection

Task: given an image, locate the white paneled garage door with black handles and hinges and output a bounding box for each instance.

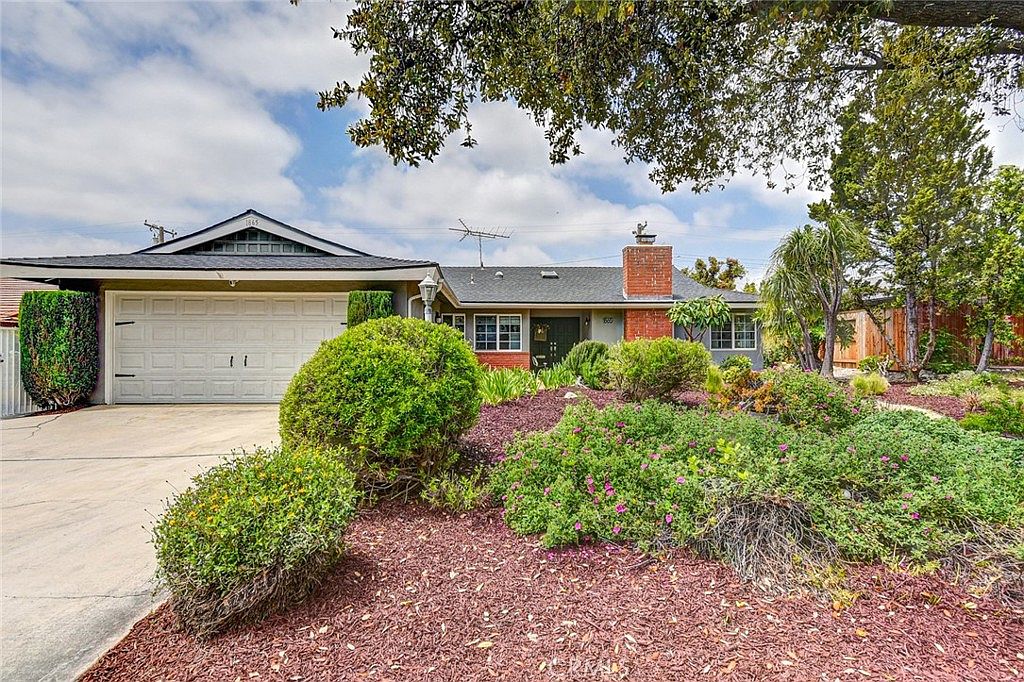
[113,293,348,402]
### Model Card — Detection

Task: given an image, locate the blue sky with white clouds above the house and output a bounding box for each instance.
[0,0,1024,279]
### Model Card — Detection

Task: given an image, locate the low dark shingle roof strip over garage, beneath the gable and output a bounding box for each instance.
[0,253,435,270]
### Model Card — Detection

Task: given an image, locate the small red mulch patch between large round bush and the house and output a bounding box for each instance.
[460,386,620,462]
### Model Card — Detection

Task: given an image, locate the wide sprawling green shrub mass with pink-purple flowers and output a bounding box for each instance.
[492,401,1024,564]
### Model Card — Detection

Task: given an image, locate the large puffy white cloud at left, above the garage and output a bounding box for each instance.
[3,58,301,222]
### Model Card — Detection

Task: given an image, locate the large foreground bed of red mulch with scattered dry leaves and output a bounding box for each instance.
[83,505,1024,682]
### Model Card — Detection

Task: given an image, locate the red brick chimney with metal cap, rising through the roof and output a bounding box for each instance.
[623,223,673,341]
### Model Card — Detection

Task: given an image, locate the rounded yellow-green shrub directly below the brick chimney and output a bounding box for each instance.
[608,337,711,400]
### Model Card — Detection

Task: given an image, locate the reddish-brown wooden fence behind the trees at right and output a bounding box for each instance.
[833,307,1024,367]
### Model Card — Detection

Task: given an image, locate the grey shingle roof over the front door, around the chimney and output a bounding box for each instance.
[441,265,758,305]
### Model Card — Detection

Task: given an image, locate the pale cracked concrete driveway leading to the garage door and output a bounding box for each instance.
[0,404,278,682]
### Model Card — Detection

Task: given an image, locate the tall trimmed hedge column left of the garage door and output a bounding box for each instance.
[17,291,99,409]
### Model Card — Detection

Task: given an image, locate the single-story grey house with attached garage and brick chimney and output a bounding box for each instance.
[0,209,761,403]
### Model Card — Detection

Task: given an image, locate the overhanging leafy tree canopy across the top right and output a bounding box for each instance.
[315,0,1024,190]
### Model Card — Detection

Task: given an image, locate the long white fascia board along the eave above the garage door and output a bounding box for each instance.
[3,264,434,283]
